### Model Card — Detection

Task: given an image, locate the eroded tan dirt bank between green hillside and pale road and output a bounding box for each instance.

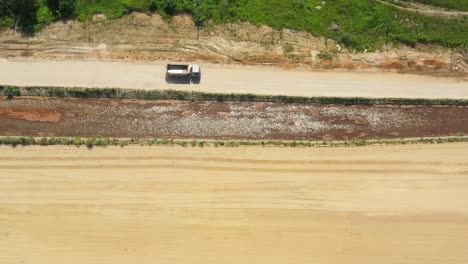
[0,13,468,76]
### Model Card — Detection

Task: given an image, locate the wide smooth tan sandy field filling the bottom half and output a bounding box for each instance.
[0,144,468,264]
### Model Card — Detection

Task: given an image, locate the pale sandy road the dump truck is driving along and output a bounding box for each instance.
[0,59,468,99]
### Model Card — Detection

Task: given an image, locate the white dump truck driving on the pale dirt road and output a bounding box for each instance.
[166,64,201,83]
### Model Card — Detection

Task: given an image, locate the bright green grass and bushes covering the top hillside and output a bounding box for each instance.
[0,0,468,50]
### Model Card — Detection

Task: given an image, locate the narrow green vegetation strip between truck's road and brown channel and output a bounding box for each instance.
[0,85,468,105]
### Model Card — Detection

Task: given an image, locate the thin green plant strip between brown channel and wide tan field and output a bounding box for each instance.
[0,136,468,149]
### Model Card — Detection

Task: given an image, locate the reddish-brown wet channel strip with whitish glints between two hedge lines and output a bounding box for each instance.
[0,98,468,140]
